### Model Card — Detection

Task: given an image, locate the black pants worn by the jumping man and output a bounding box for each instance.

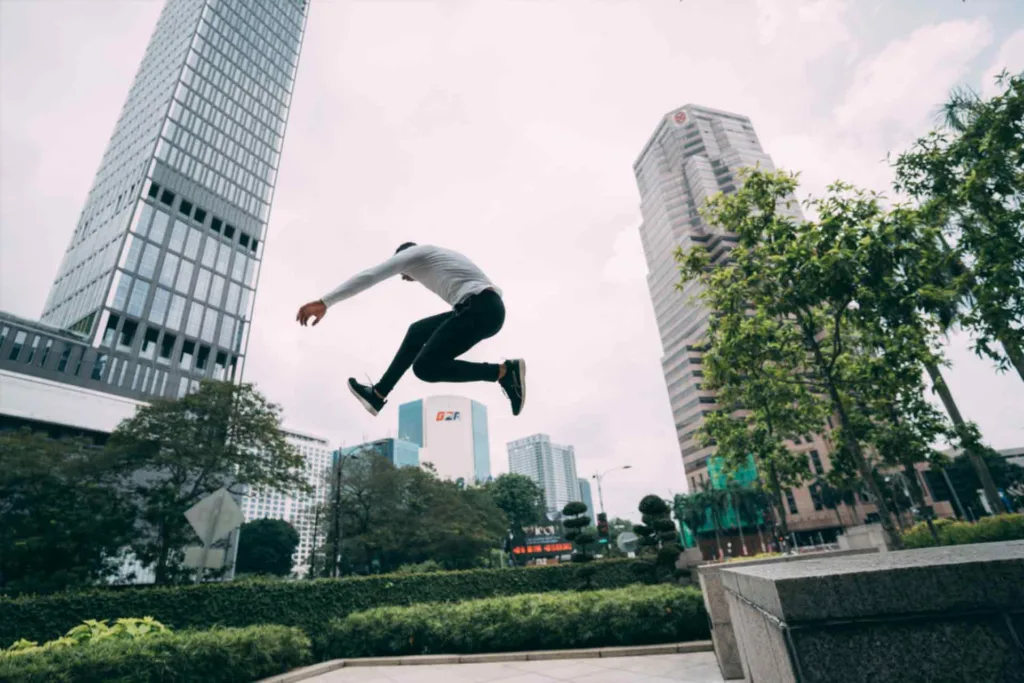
[374,290,505,396]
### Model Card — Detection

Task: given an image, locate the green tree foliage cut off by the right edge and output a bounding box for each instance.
[896,73,1024,380]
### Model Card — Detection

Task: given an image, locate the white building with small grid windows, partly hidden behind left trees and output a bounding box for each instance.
[242,428,334,573]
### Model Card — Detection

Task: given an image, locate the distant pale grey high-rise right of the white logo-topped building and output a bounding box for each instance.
[508,434,580,512]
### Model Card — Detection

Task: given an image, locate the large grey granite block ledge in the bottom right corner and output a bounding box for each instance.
[721,541,1024,683]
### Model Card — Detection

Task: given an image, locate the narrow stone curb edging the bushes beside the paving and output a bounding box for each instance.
[257,640,714,683]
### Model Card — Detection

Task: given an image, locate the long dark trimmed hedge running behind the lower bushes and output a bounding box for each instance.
[0,560,644,647]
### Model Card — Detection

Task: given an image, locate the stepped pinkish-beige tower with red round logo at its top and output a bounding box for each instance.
[633,104,800,490]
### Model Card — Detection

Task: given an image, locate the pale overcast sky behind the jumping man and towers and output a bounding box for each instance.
[0,0,1024,517]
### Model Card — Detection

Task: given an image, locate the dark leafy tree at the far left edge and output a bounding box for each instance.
[0,429,135,593]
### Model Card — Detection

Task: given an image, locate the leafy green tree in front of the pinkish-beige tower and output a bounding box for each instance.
[679,171,950,548]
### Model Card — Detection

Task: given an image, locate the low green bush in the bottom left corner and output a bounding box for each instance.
[0,626,312,683]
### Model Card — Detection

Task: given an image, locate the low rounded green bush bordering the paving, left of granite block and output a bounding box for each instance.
[314,585,709,659]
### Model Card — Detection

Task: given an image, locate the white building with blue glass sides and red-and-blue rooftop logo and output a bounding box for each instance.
[398,396,490,484]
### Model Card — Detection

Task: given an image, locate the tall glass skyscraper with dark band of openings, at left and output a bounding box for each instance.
[42,0,307,399]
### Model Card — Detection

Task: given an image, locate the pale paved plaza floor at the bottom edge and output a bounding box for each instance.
[306,652,723,683]
